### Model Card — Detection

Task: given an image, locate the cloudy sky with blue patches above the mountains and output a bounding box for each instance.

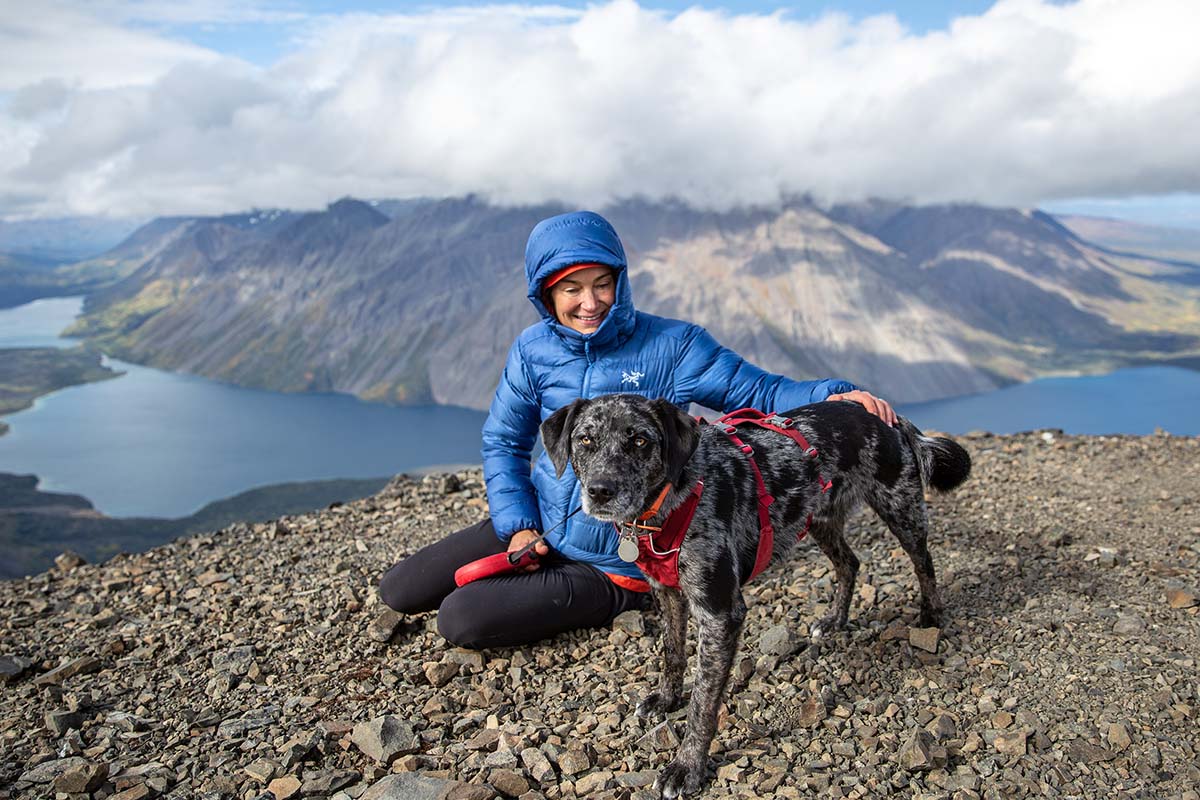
[0,0,1200,228]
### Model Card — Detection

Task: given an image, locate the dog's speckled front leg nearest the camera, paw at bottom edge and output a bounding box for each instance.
[655,599,746,798]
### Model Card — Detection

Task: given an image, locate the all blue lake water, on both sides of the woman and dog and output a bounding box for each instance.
[0,299,1200,517]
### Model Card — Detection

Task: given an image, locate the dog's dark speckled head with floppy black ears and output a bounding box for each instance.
[541,395,700,522]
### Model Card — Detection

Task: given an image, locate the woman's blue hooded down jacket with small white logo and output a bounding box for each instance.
[482,211,854,578]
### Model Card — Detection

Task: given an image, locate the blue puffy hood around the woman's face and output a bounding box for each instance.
[526,211,635,345]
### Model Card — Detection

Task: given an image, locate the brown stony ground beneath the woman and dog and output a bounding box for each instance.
[0,432,1200,800]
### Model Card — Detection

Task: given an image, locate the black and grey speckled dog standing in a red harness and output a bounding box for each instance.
[541,395,971,798]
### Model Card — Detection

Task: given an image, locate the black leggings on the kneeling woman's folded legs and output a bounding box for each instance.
[379,519,650,650]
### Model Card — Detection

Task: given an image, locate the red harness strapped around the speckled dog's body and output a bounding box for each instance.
[617,408,833,587]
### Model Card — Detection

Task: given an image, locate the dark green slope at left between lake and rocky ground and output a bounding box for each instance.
[0,473,389,578]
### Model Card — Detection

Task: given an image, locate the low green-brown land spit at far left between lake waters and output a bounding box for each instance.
[0,347,124,435]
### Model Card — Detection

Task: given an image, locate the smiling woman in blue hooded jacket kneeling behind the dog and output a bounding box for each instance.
[379,211,895,648]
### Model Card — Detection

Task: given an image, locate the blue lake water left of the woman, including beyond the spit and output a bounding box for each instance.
[0,299,485,517]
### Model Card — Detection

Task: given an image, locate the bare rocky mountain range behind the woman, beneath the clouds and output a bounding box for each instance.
[63,197,1200,408]
